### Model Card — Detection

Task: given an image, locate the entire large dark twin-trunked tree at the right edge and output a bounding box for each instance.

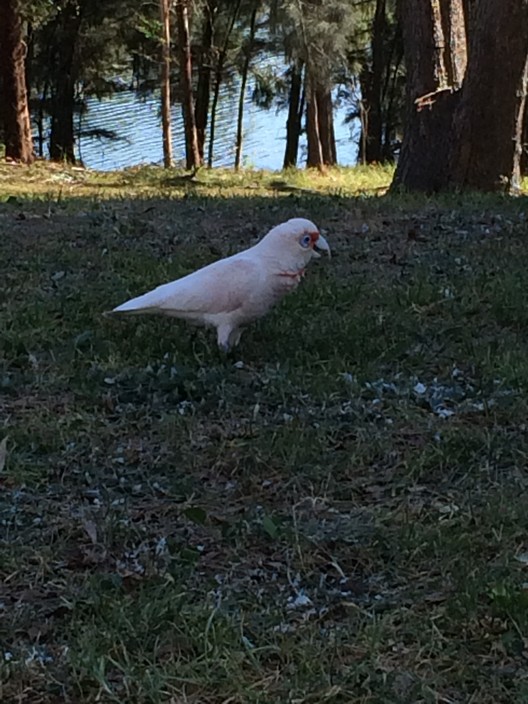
[393,0,528,191]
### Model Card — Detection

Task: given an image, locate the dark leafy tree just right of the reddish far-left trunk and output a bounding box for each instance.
[27,0,138,162]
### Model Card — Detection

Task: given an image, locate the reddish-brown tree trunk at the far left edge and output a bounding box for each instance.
[0,0,35,164]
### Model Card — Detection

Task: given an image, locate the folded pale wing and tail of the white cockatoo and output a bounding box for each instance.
[112,255,260,315]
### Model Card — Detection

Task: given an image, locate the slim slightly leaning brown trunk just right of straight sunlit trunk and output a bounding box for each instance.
[176,0,202,169]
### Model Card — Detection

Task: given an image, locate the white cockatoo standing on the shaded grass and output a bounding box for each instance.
[110,218,330,352]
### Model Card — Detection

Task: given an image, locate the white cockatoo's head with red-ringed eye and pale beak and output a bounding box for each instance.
[261,218,330,266]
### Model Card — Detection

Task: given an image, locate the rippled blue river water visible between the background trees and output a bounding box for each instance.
[77,75,359,171]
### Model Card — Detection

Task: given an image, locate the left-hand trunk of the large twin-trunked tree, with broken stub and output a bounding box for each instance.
[392,0,465,191]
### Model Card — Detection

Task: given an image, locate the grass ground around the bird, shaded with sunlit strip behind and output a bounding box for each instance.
[0,165,528,704]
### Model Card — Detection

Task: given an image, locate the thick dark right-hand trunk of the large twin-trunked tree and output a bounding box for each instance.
[451,0,528,191]
